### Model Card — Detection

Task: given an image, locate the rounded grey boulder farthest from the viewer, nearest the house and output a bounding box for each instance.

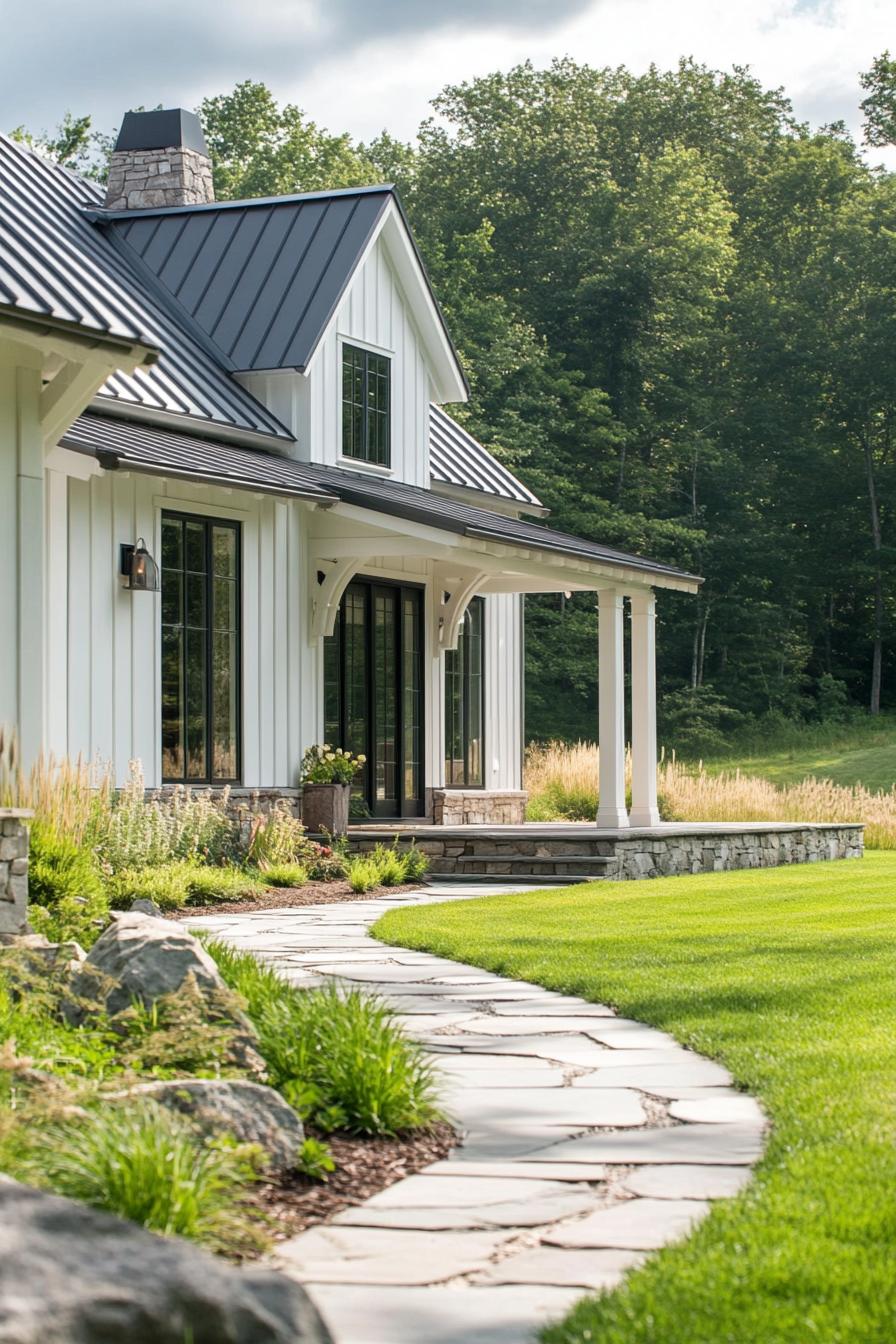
[67,910,265,1069]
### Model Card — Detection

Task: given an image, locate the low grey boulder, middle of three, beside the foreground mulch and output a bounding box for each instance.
[122,1078,305,1172]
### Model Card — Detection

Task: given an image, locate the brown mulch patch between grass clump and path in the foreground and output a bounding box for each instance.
[241,1124,457,1242]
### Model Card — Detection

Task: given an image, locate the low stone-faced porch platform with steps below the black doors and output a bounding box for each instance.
[349,821,864,884]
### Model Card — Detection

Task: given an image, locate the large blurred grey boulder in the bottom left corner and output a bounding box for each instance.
[0,1177,332,1344]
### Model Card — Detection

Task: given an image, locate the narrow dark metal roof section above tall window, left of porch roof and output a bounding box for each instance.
[60,413,336,503]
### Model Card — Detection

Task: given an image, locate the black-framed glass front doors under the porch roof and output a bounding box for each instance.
[324,579,423,817]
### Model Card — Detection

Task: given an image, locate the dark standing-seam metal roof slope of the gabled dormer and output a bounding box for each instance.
[100,187,392,372]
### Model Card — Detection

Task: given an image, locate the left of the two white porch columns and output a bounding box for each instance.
[598,589,629,828]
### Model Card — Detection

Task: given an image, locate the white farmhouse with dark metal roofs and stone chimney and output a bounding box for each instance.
[0,110,850,875]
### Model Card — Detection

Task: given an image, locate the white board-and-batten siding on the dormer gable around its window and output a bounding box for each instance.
[239,238,431,487]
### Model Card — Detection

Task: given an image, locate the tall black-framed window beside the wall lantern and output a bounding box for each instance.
[161,513,242,784]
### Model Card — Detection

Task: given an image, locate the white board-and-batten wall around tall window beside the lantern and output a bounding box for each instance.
[46,454,316,786]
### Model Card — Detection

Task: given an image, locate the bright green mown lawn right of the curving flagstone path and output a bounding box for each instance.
[375,852,896,1344]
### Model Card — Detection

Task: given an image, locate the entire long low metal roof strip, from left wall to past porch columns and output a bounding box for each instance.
[63,415,700,583]
